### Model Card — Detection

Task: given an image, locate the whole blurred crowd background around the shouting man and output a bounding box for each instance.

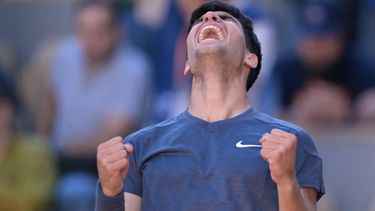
[0,0,375,211]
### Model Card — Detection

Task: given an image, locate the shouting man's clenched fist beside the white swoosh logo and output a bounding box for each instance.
[260,129,297,185]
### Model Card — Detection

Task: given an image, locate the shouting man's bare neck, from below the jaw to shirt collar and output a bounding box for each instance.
[189,67,250,122]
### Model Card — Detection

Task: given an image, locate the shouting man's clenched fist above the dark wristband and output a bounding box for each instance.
[96,136,133,196]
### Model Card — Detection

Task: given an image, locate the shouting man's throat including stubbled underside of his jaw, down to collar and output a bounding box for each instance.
[189,48,250,122]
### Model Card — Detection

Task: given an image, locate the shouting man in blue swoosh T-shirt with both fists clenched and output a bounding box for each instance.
[96,1,324,211]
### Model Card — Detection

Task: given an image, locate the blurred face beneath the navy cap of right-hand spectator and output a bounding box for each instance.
[298,34,344,70]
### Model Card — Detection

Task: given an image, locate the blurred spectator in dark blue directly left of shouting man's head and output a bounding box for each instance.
[123,0,205,122]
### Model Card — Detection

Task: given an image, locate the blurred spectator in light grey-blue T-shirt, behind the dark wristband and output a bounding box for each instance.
[39,0,149,211]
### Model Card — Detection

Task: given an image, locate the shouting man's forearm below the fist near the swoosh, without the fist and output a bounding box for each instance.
[277,180,316,211]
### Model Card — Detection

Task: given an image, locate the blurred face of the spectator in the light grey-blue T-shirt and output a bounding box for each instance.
[77,5,118,63]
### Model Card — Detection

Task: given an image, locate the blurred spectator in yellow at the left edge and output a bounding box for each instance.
[0,70,56,211]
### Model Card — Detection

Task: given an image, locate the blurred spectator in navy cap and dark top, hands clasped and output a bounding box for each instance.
[267,1,375,125]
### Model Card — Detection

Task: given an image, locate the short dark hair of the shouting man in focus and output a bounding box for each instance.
[188,0,262,91]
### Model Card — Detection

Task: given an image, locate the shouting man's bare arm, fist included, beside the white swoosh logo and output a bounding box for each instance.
[260,129,317,211]
